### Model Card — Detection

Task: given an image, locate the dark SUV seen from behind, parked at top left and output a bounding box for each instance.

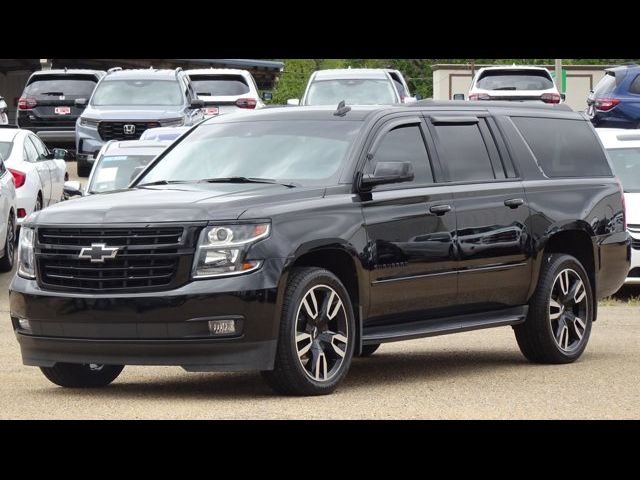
[17,69,105,149]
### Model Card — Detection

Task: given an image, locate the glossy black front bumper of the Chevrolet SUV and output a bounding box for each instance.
[9,259,284,371]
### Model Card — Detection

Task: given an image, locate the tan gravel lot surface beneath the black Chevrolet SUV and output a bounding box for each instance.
[0,163,640,419]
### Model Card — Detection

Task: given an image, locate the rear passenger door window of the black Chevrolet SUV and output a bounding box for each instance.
[434,124,495,182]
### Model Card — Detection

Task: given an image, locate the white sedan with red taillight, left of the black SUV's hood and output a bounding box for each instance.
[0,125,67,225]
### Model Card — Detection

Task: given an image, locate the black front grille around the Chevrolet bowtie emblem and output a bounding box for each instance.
[36,227,193,292]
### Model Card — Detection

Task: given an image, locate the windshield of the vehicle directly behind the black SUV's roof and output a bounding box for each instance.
[305,78,398,106]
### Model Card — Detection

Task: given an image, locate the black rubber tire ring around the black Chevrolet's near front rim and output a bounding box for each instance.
[280,269,356,391]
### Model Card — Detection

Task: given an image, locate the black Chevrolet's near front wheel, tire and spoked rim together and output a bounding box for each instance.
[262,268,356,395]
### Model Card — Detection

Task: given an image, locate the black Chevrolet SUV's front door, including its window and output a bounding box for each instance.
[362,117,457,323]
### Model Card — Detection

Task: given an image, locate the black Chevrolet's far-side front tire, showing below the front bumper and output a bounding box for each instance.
[40,363,124,388]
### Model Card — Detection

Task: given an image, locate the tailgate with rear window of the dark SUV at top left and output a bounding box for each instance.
[21,73,97,127]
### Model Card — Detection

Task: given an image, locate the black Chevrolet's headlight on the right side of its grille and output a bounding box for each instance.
[193,223,271,278]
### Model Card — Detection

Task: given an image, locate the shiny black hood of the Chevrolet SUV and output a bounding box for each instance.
[31,183,324,225]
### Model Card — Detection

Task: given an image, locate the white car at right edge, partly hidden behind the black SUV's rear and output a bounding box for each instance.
[596,128,640,285]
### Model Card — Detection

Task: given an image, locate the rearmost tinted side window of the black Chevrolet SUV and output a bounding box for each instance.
[511,117,611,177]
